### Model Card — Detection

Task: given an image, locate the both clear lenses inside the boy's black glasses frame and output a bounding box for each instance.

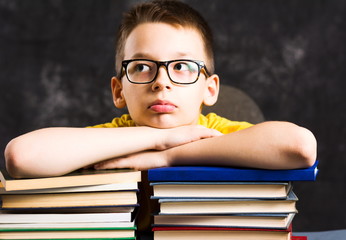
[127,60,199,84]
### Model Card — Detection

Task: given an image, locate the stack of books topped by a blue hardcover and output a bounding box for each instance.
[148,162,317,240]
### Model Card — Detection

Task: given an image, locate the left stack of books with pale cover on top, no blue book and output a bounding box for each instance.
[0,169,141,239]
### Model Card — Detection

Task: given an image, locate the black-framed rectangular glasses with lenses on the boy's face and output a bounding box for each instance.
[122,59,209,84]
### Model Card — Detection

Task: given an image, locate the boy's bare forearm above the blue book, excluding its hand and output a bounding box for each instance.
[167,122,316,169]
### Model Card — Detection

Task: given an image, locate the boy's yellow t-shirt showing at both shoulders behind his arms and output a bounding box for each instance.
[89,113,252,134]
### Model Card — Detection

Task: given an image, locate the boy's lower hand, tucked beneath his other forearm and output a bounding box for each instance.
[94,151,167,170]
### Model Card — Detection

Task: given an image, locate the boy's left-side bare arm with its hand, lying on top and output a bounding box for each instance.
[5,126,221,177]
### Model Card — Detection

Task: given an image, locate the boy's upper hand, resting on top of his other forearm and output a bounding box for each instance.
[156,125,223,150]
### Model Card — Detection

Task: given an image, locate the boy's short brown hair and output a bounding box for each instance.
[115,0,214,77]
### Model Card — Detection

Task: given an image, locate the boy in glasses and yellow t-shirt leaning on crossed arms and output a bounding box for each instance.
[5,1,316,178]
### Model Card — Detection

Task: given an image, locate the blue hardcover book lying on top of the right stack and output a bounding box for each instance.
[148,161,318,182]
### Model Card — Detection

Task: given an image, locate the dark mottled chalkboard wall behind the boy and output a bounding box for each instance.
[0,0,346,231]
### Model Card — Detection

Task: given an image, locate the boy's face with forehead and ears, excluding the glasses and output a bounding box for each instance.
[112,23,219,128]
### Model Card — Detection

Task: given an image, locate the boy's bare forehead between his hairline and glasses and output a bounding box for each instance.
[124,23,206,61]
